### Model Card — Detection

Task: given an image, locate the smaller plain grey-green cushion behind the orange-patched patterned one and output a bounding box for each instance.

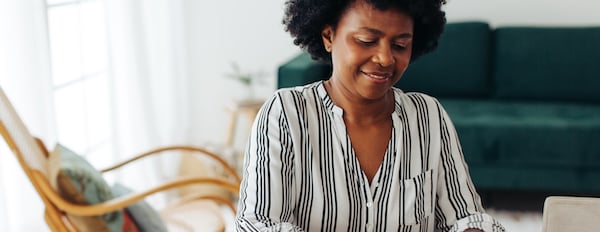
[112,183,167,232]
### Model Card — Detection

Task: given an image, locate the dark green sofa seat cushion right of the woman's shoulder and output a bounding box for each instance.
[441,100,600,169]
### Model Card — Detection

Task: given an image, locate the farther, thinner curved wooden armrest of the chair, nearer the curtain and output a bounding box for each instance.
[100,145,241,183]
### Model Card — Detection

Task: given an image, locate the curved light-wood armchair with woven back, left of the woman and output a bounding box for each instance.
[0,88,240,231]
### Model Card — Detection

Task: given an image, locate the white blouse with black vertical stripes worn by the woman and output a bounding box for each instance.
[236,81,504,232]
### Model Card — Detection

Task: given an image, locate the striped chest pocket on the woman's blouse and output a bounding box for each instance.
[400,170,435,225]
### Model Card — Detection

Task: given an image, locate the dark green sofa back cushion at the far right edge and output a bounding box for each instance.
[494,27,600,102]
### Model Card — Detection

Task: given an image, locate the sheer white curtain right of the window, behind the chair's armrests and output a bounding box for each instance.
[106,0,190,202]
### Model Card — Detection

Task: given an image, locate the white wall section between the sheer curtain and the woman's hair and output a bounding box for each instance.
[185,0,299,147]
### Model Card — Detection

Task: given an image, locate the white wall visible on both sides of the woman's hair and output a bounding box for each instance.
[185,0,600,147]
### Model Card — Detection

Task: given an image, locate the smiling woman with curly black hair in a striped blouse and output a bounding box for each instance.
[236,0,504,231]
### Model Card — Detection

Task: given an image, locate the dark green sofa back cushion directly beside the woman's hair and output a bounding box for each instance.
[396,22,492,97]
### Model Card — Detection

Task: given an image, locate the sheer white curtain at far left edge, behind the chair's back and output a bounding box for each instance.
[0,0,55,231]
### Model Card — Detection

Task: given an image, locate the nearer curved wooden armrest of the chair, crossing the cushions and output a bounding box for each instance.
[32,170,239,216]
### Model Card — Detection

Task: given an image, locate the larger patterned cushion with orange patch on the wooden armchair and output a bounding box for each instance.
[49,144,137,231]
